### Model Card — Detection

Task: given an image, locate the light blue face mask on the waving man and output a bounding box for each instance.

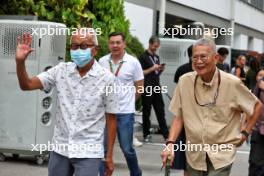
[71,48,92,67]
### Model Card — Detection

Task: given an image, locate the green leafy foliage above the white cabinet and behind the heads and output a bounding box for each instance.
[0,0,143,59]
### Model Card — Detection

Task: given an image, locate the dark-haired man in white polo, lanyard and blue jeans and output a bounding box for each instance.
[99,32,144,176]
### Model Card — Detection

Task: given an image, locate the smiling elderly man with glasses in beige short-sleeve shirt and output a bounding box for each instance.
[162,39,262,176]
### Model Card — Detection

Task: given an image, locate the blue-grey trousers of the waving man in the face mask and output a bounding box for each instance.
[48,152,101,176]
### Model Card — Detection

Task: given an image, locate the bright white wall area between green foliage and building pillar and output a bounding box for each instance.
[124,2,153,48]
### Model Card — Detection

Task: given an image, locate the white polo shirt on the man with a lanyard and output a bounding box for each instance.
[99,53,144,113]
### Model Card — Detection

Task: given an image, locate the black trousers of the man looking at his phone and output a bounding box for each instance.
[142,92,169,139]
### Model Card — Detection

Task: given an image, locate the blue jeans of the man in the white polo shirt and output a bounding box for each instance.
[100,113,142,176]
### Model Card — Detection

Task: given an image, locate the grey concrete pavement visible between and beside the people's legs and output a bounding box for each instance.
[0,134,249,176]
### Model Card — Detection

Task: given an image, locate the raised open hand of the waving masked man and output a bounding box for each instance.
[16,33,34,62]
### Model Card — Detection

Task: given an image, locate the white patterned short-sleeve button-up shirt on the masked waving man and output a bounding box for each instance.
[37,61,118,158]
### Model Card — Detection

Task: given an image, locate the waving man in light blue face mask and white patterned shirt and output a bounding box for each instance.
[16,28,118,176]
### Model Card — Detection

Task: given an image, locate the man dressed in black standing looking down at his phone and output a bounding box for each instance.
[139,36,169,142]
